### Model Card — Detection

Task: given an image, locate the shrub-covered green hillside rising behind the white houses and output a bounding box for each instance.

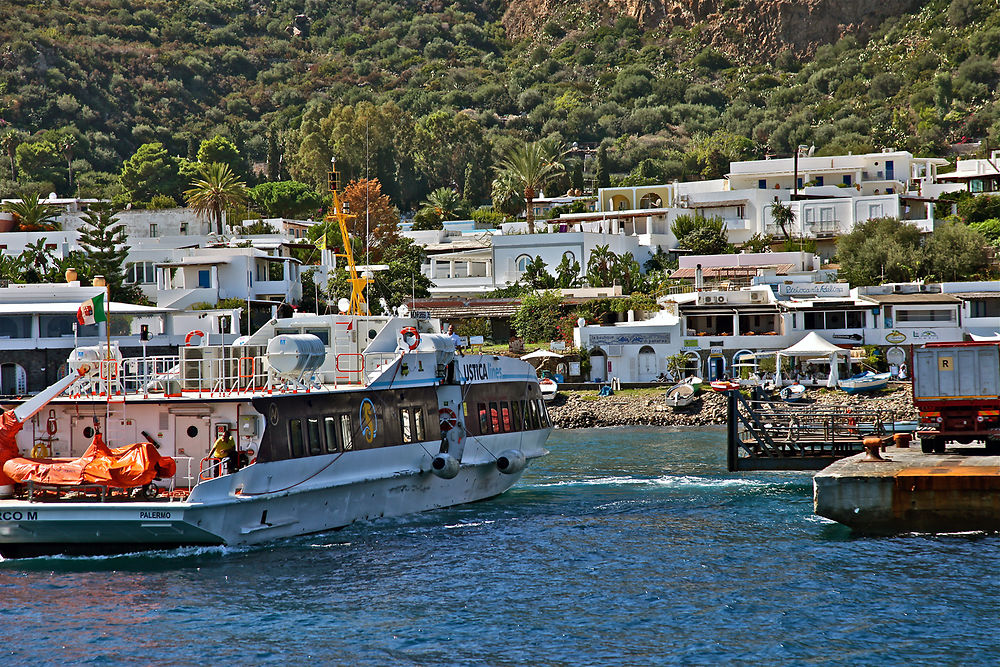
[0,0,1000,209]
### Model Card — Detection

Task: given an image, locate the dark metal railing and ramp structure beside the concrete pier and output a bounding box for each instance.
[726,390,896,472]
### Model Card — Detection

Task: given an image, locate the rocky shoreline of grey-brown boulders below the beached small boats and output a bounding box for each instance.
[548,382,919,428]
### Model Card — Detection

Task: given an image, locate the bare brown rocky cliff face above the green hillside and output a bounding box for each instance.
[503,0,922,60]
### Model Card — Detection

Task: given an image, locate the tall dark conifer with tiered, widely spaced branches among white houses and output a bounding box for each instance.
[79,205,136,301]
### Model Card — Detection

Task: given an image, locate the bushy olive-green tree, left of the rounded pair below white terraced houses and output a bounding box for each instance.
[837,218,921,286]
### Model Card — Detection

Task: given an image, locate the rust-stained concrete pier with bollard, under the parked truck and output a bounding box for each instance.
[813,447,1000,534]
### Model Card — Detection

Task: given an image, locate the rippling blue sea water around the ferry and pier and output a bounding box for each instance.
[0,428,1000,666]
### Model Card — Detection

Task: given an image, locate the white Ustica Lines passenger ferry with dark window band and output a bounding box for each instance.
[0,315,551,557]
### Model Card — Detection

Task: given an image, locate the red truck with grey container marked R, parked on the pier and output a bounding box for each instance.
[913,343,1000,453]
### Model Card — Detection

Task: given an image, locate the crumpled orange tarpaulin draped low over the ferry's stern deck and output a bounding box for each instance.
[3,433,177,489]
